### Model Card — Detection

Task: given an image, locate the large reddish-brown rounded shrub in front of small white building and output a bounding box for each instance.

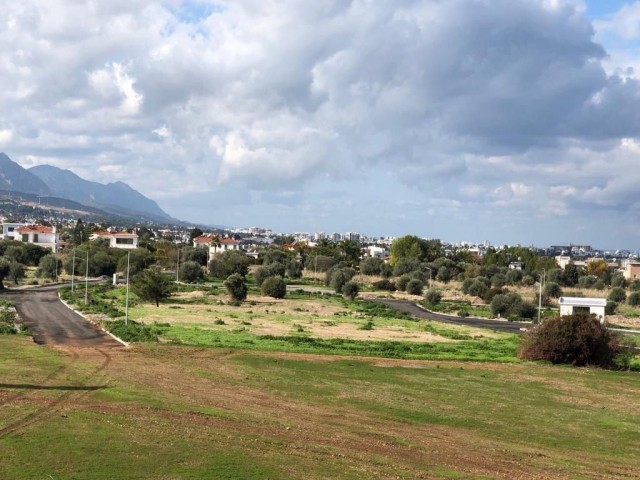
[518,314,623,368]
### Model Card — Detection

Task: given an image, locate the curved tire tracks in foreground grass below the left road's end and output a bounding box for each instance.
[0,349,112,439]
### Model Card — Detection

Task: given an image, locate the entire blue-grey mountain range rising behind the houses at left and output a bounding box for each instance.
[0,153,174,221]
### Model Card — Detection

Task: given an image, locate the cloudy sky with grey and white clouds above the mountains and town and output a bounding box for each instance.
[0,0,640,250]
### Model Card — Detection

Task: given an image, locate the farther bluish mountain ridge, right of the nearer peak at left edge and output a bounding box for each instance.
[28,165,171,220]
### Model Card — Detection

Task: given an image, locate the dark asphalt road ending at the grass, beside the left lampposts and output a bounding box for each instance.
[2,287,122,348]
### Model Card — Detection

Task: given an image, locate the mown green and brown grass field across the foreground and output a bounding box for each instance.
[0,336,640,480]
